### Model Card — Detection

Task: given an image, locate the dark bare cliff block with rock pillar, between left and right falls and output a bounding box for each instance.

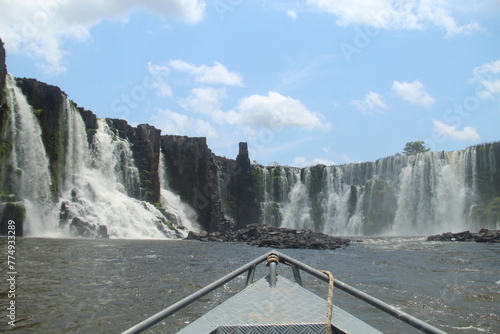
[161,135,260,232]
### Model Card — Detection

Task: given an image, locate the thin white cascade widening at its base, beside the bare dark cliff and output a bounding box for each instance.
[158,152,200,237]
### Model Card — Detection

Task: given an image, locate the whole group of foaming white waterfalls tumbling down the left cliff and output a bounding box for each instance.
[2,75,197,239]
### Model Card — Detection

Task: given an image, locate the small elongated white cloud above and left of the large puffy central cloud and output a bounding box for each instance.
[170,59,243,86]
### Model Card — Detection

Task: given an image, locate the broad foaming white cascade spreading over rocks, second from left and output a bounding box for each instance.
[59,105,176,239]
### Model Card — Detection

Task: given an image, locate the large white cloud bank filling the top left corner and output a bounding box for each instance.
[0,0,205,74]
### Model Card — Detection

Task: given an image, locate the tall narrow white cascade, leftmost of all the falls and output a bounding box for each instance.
[6,74,57,235]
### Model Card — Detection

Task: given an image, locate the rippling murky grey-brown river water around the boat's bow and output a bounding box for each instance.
[0,238,500,334]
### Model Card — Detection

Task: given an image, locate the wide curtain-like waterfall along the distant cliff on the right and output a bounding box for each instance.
[254,147,490,235]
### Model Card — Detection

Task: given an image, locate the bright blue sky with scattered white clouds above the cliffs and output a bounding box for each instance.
[0,0,500,167]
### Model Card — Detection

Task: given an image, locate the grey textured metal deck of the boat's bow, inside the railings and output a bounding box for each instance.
[178,276,380,334]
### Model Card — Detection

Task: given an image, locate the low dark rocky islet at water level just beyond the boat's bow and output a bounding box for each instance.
[187,224,350,249]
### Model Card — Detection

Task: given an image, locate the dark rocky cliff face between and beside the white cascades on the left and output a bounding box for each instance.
[0,40,259,232]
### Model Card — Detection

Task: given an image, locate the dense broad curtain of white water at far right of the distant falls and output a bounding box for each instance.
[391,149,476,235]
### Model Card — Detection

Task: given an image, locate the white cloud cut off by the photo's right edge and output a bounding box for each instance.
[471,59,500,100]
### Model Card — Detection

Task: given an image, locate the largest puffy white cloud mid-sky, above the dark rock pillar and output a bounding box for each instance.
[226,92,331,131]
